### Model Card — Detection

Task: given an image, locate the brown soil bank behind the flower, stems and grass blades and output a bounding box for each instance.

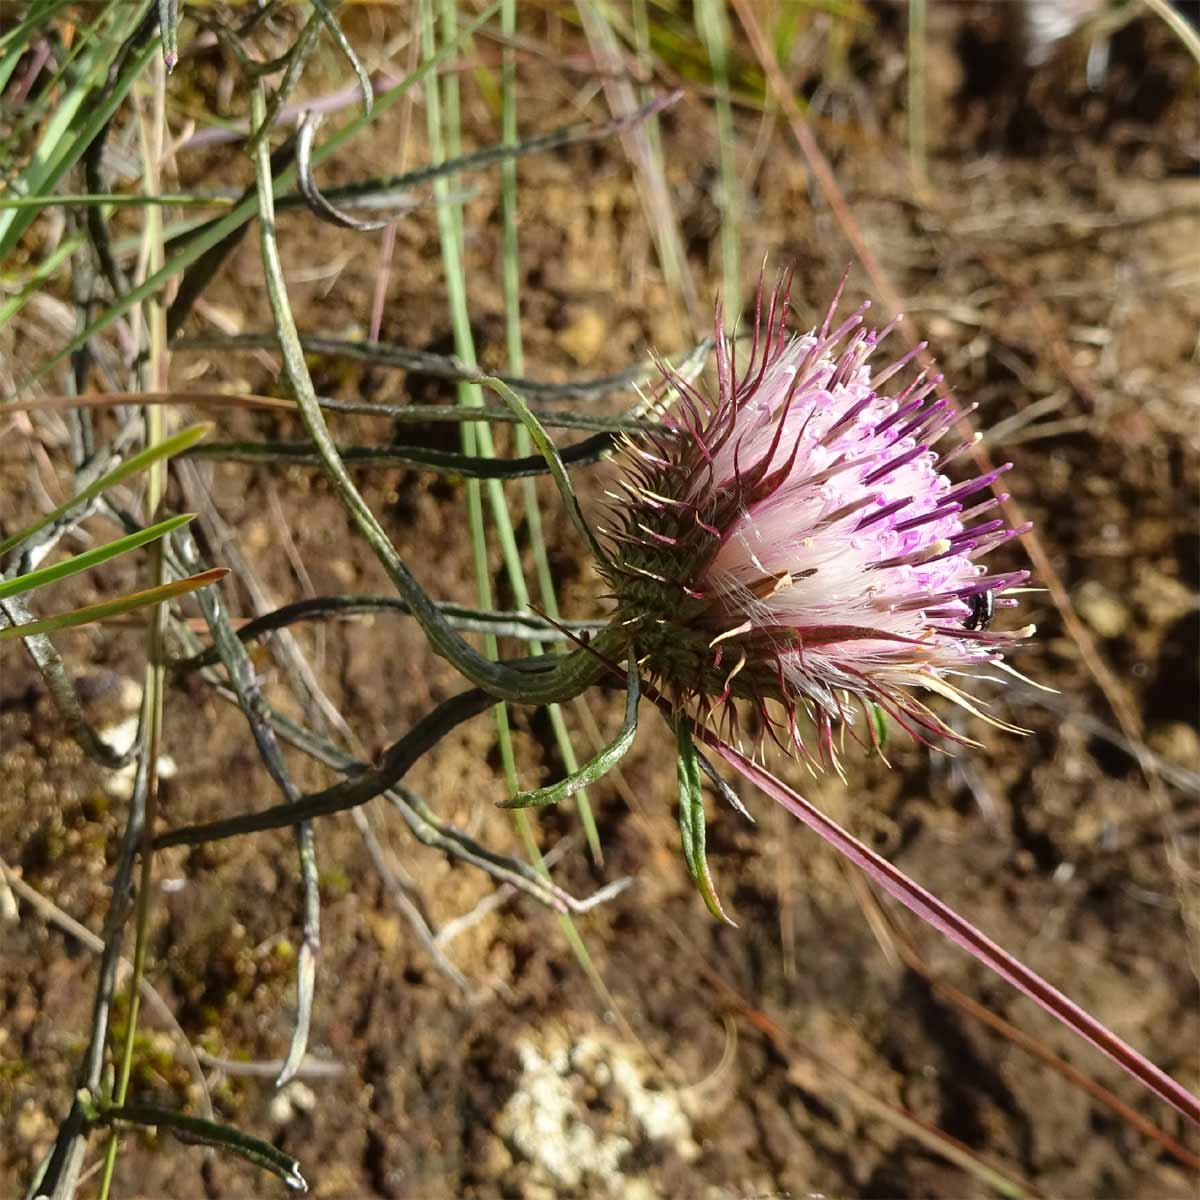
[0,5,1200,1200]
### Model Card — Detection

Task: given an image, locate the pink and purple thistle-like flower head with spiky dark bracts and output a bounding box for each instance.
[604,280,1033,766]
